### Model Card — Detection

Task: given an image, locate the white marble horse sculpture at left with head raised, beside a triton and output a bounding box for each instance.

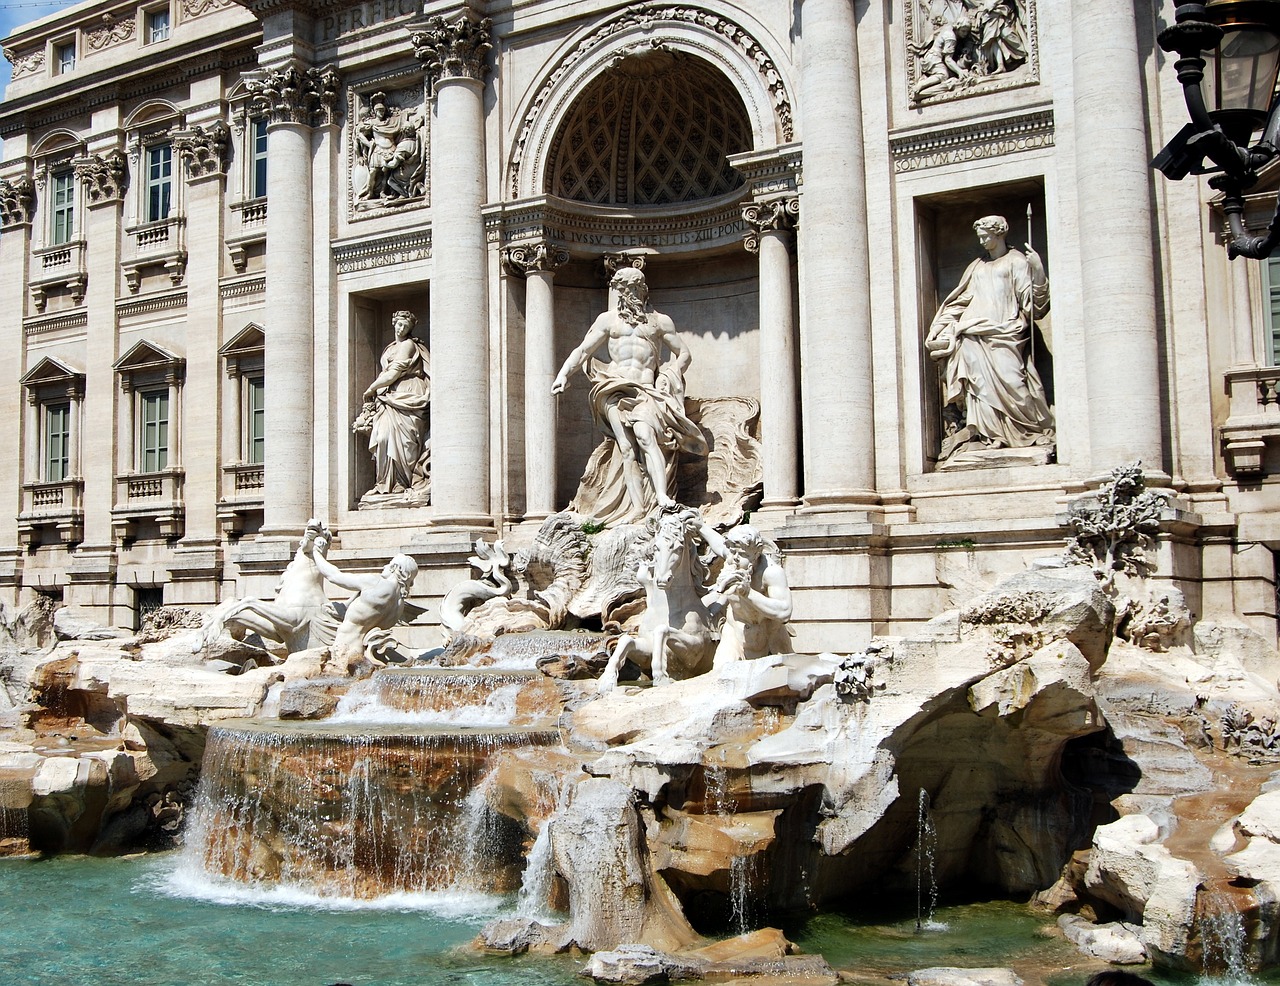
[192,519,337,654]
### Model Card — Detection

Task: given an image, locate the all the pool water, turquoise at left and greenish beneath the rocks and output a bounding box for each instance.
[0,854,1276,986]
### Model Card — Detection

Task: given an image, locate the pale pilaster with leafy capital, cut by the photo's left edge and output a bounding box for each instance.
[0,174,40,576]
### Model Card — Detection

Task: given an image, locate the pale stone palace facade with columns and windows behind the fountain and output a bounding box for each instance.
[0,0,1280,652]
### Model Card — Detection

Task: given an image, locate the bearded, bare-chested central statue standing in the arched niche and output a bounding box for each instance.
[552,266,707,524]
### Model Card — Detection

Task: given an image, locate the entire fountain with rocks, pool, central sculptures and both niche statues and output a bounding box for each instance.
[0,258,1280,983]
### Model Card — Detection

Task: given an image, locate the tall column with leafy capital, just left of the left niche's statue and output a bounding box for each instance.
[246,64,338,535]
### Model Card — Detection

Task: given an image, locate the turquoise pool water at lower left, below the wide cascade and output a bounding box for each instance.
[0,854,582,986]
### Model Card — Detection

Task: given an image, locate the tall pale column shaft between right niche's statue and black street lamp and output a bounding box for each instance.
[1071,0,1165,476]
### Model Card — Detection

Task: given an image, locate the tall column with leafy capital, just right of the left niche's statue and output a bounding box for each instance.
[412,13,493,526]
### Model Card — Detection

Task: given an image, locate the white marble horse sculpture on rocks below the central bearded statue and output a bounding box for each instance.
[599,507,717,694]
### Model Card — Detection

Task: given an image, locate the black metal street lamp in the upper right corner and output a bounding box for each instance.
[1152,0,1280,260]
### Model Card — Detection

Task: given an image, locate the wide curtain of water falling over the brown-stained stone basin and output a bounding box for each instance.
[177,722,559,899]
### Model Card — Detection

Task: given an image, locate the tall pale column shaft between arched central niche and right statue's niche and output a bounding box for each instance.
[800,0,876,510]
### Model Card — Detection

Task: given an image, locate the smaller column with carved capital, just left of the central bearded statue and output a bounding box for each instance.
[503,242,568,520]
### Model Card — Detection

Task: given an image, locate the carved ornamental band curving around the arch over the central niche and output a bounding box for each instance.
[508,0,788,195]
